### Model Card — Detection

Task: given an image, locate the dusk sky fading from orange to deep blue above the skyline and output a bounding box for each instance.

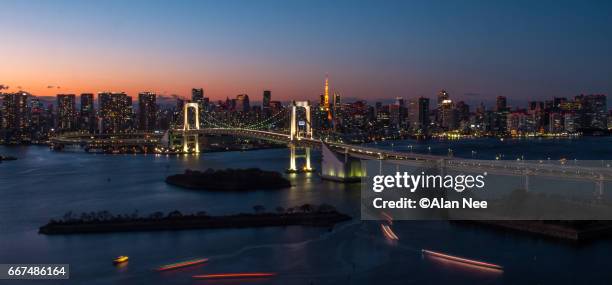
[0,0,612,105]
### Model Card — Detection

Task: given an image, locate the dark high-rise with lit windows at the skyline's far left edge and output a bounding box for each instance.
[1,91,30,143]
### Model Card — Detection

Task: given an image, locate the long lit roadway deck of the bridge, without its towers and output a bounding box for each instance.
[51,128,612,183]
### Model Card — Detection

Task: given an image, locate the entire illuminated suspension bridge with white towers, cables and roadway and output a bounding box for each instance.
[51,101,612,194]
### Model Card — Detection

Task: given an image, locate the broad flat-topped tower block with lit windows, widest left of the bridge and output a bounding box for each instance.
[98,92,132,133]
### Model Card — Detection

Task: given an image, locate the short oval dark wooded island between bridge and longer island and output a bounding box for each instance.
[166,168,291,191]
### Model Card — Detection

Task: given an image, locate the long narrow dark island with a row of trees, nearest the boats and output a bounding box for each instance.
[38,204,351,235]
